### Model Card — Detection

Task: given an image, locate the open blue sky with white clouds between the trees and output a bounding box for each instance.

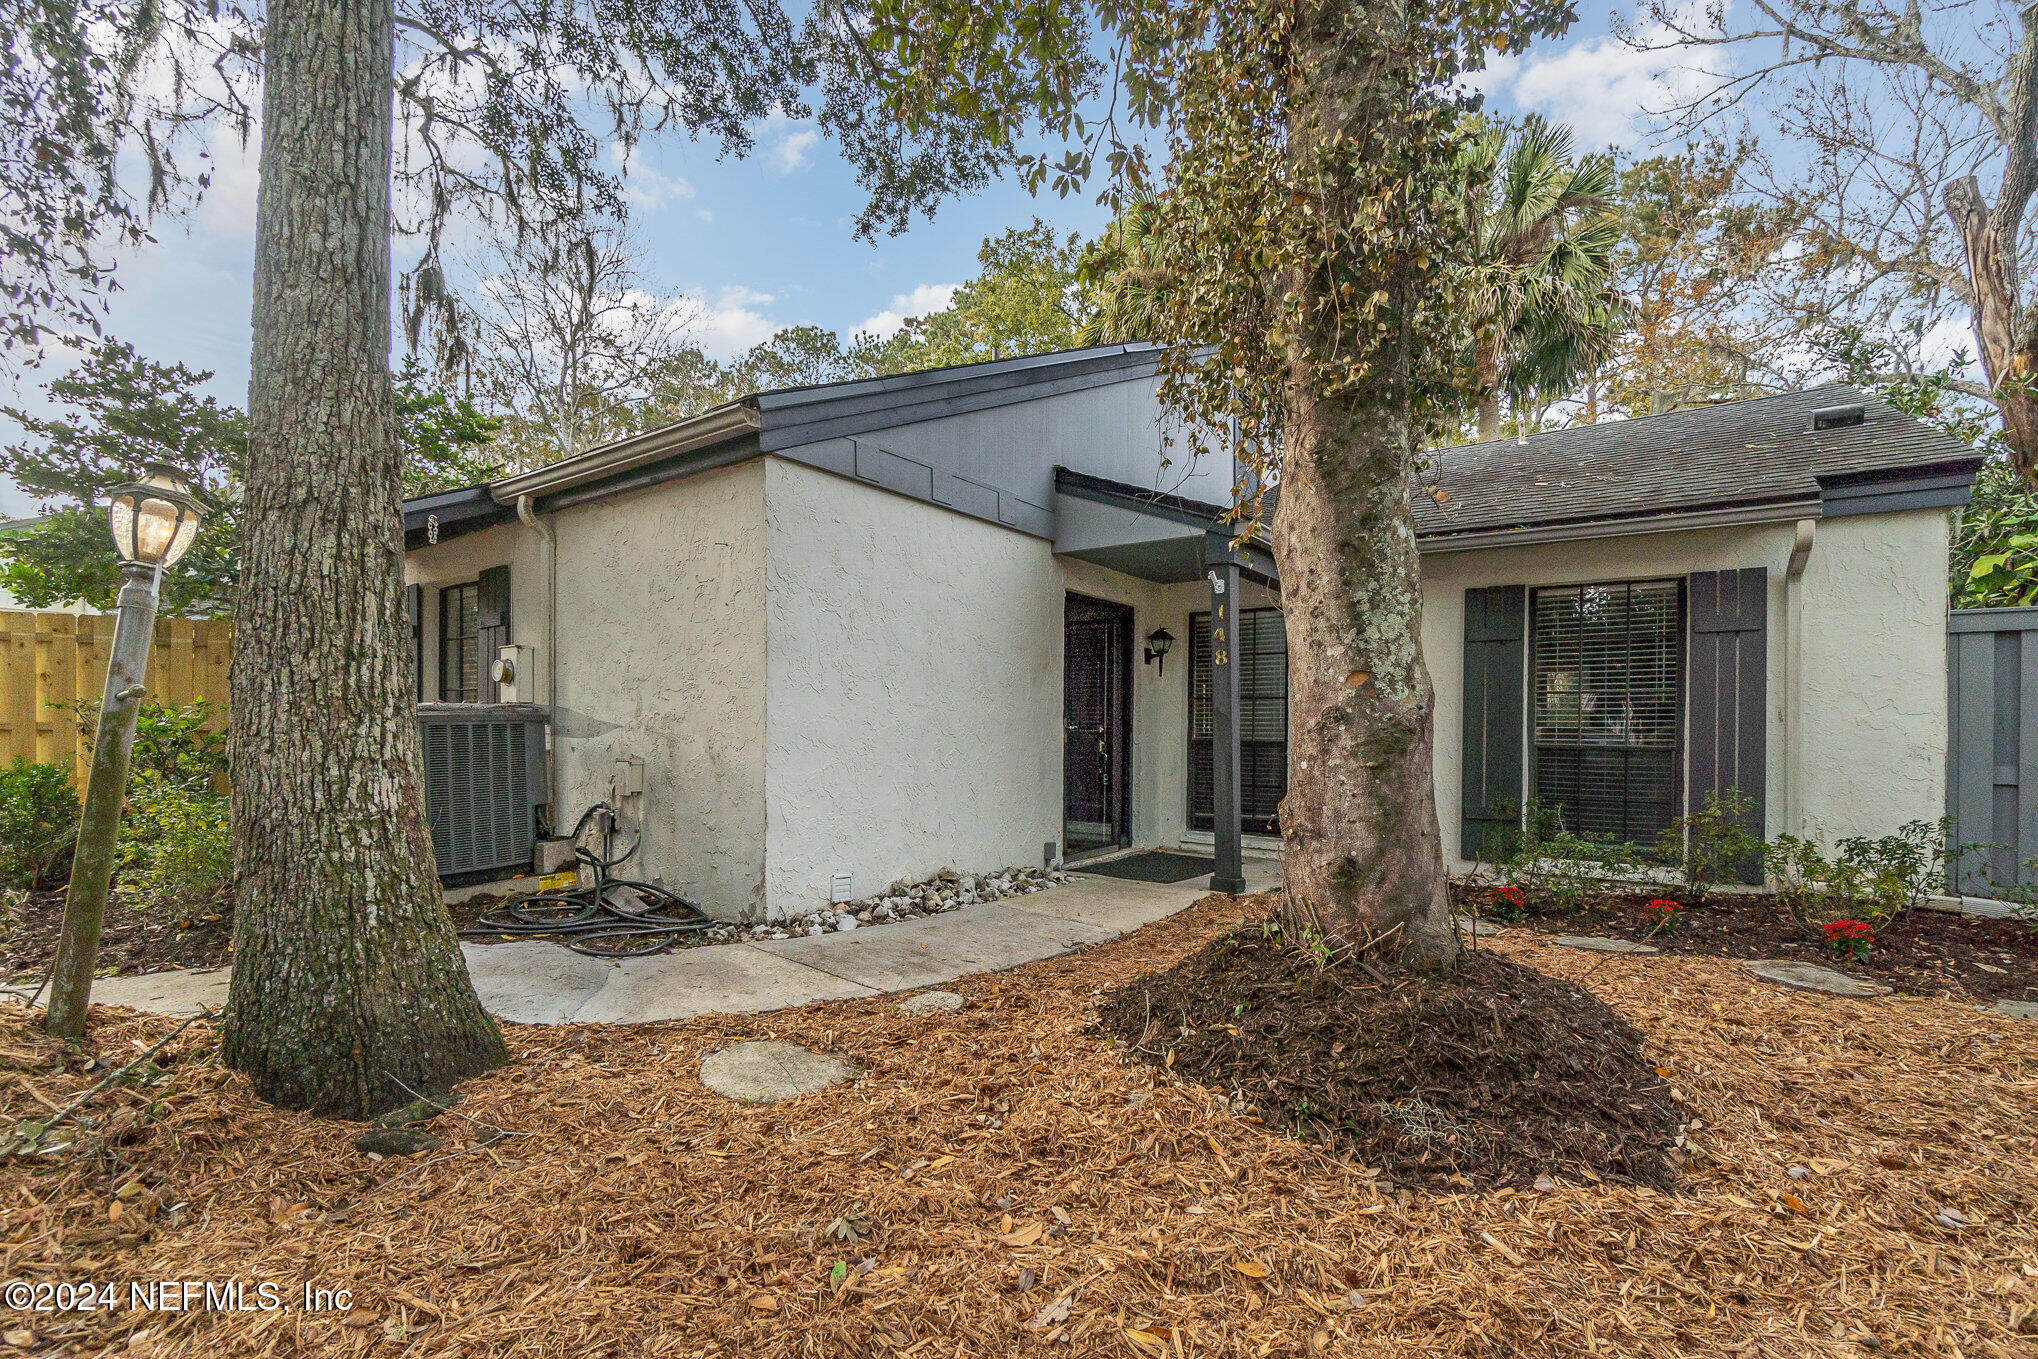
[0,4,1683,515]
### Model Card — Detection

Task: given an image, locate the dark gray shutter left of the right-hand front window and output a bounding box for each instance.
[1457,585,1529,860]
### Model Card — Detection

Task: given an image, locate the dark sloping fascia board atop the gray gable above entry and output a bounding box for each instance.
[754,346,1162,452]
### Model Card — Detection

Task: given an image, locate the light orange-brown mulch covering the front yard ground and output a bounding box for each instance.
[0,899,2038,1359]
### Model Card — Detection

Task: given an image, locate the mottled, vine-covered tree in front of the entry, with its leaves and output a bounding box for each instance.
[878,0,1569,968]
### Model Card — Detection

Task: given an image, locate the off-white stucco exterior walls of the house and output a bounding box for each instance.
[408,456,1948,919]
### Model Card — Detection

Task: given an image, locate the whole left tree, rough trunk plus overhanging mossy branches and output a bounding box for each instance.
[0,0,1009,1117]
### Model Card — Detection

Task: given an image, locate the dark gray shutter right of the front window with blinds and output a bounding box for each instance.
[1685,566,1769,882]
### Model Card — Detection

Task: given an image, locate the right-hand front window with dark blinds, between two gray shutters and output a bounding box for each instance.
[1531,581,1683,844]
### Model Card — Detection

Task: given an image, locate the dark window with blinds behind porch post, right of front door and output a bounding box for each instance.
[1188,609,1288,835]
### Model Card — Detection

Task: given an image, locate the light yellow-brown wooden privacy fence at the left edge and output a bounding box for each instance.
[0,609,232,789]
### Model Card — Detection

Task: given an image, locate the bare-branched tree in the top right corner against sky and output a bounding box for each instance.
[1626,0,2038,481]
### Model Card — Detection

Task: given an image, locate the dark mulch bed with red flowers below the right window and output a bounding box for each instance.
[1451,886,2038,1000]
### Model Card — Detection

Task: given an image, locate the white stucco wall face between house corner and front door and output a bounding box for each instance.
[762,458,1062,915]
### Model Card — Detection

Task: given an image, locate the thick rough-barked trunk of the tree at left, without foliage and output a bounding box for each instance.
[224,0,503,1119]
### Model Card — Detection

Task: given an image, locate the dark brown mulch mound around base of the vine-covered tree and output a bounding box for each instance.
[1098,927,1683,1190]
